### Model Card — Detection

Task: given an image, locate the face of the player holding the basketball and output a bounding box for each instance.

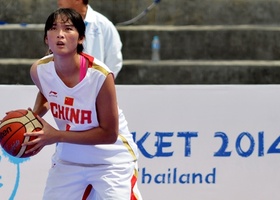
[46,16,83,54]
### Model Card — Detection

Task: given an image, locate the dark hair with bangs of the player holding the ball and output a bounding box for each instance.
[44,8,86,53]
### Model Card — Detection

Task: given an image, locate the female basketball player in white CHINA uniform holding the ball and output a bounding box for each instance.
[24,9,141,200]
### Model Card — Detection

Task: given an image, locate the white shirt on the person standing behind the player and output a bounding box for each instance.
[83,5,123,78]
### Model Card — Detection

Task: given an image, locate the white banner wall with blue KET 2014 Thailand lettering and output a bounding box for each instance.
[0,85,280,200]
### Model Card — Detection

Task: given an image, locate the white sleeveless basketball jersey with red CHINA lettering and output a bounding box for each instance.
[37,54,138,165]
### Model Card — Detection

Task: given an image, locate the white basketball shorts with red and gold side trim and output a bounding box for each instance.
[43,161,142,200]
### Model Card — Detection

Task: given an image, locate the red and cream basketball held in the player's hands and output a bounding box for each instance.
[0,109,43,158]
